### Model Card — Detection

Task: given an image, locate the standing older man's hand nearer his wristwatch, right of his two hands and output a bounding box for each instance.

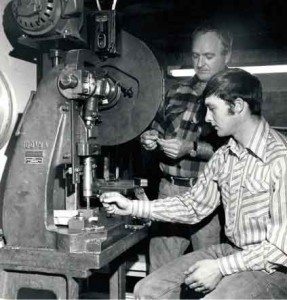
[158,139,194,159]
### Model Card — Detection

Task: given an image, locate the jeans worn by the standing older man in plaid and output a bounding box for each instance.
[149,178,221,273]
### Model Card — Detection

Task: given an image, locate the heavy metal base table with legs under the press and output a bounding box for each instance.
[0,226,147,299]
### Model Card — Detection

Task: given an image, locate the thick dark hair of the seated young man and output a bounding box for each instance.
[202,68,262,116]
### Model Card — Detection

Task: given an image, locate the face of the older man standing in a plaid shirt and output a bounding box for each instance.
[192,32,229,81]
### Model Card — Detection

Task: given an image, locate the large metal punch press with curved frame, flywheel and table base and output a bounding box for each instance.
[0,0,163,299]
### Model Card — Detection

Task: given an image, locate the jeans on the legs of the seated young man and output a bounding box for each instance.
[134,244,287,299]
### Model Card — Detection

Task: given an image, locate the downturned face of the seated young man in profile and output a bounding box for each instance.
[205,95,237,136]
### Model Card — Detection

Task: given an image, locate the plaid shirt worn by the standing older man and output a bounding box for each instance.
[151,77,224,178]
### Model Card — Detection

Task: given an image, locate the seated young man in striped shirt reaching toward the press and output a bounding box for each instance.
[101,69,287,299]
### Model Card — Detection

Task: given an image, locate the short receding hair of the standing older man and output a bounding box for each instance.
[191,22,233,55]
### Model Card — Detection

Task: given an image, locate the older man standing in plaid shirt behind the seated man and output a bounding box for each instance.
[141,24,232,272]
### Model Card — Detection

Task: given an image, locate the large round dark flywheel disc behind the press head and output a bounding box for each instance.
[61,31,163,146]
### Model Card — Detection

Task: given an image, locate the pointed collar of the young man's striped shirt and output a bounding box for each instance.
[227,118,270,162]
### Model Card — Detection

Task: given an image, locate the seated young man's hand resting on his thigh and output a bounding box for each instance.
[184,259,223,293]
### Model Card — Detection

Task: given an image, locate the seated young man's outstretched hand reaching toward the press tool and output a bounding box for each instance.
[100,192,132,216]
